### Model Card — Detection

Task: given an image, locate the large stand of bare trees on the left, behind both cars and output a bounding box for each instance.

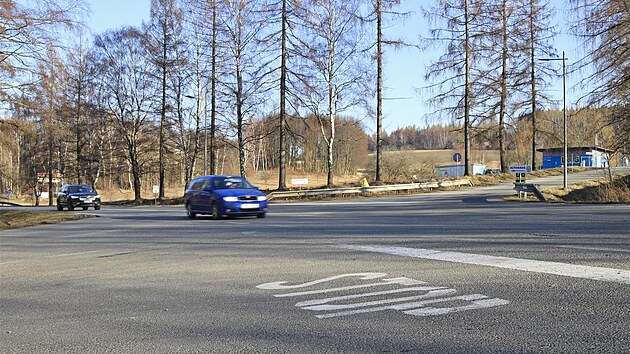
[1,0,374,201]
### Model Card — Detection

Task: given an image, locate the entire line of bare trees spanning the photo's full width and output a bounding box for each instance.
[0,0,630,201]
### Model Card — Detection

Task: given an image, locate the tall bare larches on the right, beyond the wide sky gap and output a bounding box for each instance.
[425,0,630,174]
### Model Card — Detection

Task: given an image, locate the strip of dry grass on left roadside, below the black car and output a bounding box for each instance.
[0,210,95,231]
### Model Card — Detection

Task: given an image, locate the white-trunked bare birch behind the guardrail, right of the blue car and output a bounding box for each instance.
[296,0,372,186]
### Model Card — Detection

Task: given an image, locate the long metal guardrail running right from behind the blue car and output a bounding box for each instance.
[267,179,472,200]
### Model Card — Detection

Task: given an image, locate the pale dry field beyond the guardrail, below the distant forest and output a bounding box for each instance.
[370,150,499,168]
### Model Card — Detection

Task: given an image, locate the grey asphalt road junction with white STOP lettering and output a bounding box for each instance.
[0,171,630,353]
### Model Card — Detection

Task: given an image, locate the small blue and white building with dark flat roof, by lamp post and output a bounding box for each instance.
[536,146,613,168]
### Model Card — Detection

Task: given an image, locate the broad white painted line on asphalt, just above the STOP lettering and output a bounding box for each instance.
[337,245,630,284]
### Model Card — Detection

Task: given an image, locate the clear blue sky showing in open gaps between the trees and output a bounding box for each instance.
[88,0,576,133]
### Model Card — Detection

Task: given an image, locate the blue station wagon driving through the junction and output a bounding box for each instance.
[184,176,267,220]
